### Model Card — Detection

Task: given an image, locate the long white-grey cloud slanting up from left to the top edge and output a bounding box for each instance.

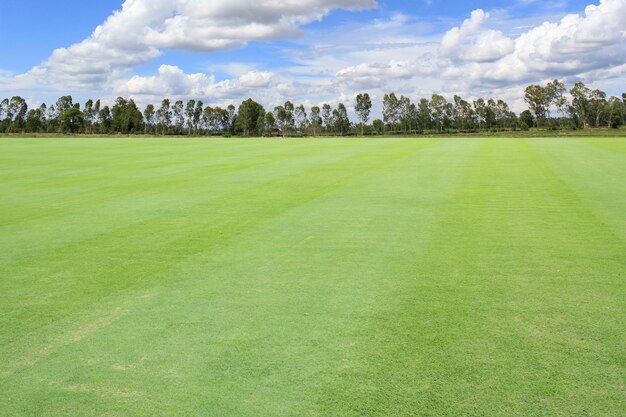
[8,0,376,89]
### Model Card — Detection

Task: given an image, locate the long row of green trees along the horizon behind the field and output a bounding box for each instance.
[0,80,626,136]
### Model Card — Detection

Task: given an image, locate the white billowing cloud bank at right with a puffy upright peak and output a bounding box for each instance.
[337,0,626,91]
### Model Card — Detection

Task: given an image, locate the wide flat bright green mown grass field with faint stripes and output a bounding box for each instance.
[0,138,626,417]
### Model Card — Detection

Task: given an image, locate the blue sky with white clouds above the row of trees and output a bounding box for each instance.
[0,0,626,113]
